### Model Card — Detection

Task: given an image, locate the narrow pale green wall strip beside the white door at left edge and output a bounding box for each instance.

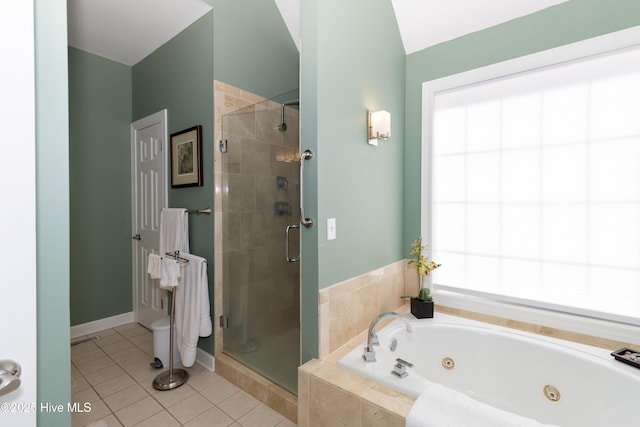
[36,0,71,427]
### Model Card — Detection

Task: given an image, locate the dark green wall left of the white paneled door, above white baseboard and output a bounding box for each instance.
[69,47,132,326]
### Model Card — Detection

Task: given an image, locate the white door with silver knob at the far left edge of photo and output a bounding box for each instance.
[0,1,38,427]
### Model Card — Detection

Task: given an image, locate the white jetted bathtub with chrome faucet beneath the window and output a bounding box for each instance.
[338,313,640,427]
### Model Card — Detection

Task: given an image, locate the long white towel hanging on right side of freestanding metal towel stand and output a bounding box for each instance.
[173,253,212,367]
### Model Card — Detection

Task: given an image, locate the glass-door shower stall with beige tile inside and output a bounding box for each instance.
[220,92,305,393]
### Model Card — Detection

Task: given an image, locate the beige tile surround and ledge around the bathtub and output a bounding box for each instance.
[306,260,640,427]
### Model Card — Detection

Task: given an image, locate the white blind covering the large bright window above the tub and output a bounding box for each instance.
[431,44,640,324]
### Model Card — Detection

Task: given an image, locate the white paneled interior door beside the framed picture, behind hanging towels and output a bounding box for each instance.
[131,110,168,328]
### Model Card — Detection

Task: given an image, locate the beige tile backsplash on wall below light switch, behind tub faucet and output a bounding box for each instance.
[318,260,417,359]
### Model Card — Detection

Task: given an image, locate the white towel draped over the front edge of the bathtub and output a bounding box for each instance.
[405,383,551,427]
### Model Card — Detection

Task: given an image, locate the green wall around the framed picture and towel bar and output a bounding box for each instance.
[134,12,214,354]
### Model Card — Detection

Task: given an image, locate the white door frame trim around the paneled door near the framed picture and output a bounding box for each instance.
[130,108,169,322]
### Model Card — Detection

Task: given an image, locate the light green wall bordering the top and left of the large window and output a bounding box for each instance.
[404,0,640,254]
